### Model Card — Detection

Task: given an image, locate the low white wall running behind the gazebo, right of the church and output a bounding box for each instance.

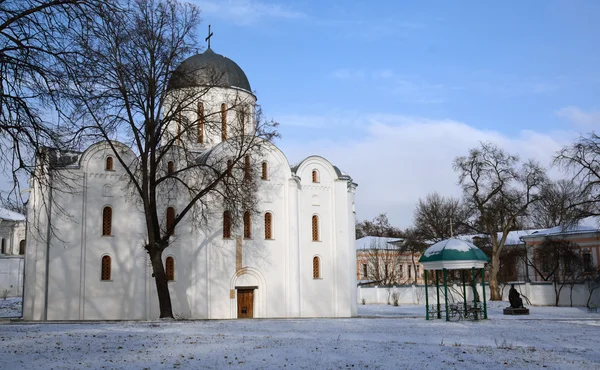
[357,283,600,306]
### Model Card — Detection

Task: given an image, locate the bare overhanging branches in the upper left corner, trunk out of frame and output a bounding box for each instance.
[0,0,105,201]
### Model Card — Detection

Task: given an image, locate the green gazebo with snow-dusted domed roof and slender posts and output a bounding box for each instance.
[419,238,489,321]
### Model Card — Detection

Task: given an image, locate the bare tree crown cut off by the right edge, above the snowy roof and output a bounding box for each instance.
[554,132,600,219]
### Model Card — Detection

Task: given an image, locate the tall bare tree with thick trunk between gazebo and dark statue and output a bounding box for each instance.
[454,143,547,300]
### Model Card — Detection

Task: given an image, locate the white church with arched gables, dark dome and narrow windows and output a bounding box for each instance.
[23,46,357,320]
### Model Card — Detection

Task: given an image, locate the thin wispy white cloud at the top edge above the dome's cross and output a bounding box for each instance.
[195,0,306,25]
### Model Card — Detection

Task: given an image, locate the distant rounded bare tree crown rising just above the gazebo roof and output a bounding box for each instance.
[411,192,469,242]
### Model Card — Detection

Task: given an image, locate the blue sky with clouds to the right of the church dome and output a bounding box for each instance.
[195,0,600,227]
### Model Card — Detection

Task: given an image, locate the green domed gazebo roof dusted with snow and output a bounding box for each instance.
[419,238,489,270]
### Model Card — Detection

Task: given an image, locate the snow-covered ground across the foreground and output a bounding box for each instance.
[0,302,600,369]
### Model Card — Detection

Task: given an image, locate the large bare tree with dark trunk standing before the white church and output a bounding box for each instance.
[57,0,276,318]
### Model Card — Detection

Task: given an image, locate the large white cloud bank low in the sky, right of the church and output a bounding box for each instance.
[280,114,576,228]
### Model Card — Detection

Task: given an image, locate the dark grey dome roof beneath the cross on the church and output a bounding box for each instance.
[167,48,252,92]
